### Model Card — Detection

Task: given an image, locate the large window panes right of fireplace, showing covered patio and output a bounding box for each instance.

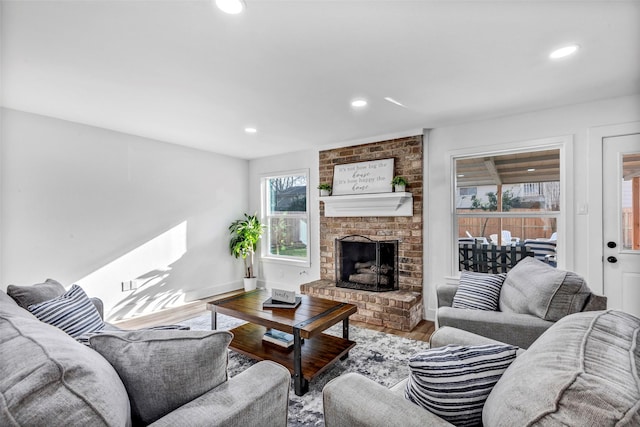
[454,149,561,266]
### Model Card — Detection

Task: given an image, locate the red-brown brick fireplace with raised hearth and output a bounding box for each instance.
[301,135,423,331]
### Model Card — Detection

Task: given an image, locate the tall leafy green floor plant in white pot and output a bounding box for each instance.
[229,213,264,291]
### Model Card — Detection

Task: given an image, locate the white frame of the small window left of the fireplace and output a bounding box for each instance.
[260,169,311,267]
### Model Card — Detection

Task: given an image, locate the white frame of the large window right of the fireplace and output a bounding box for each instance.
[447,135,574,277]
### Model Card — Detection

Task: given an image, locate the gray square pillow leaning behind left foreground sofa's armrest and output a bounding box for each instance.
[89,330,233,425]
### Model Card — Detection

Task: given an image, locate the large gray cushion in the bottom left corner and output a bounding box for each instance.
[0,312,131,427]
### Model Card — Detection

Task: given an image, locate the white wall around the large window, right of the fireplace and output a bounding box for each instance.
[425,96,640,319]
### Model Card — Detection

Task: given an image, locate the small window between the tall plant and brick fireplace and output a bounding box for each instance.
[261,170,309,266]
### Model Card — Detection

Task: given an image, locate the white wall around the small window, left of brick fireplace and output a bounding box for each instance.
[249,150,320,292]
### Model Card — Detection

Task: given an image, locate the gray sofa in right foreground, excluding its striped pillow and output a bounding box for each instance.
[323,311,640,427]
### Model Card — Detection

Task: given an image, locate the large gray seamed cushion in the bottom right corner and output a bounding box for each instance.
[483,311,640,427]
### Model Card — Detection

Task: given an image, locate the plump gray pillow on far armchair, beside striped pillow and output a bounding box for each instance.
[500,257,591,322]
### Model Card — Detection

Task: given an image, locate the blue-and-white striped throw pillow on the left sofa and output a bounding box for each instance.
[28,285,104,339]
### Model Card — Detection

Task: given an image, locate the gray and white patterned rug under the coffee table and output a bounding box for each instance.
[180,314,429,426]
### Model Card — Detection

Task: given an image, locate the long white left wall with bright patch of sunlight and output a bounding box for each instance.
[0,109,249,320]
